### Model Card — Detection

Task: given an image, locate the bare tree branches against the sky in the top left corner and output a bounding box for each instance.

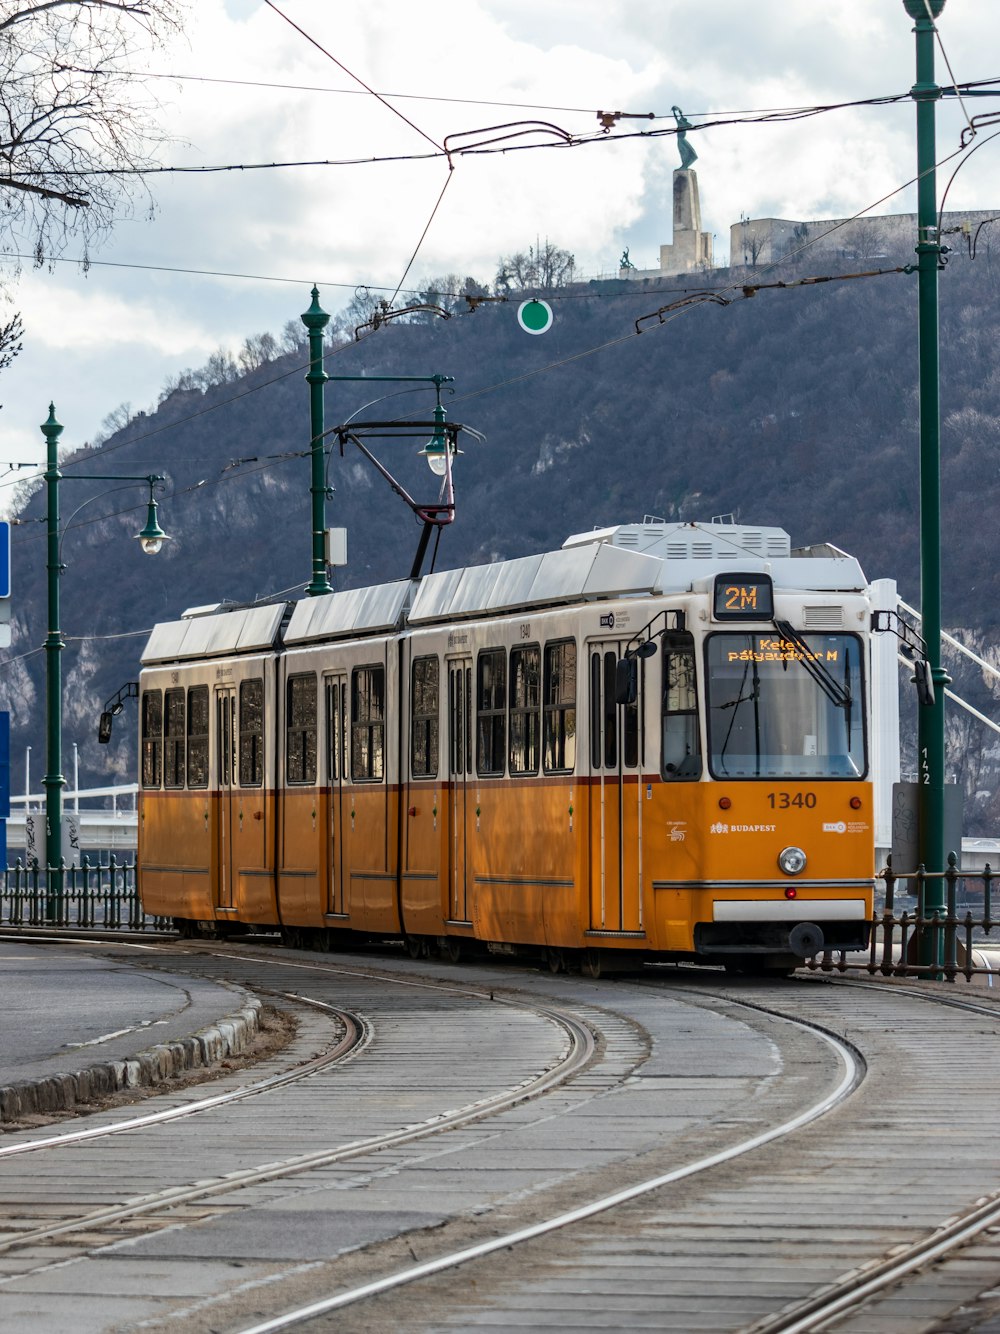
[0,0,185,263]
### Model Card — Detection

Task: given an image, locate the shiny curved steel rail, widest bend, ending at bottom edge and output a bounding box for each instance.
[230,998,864,1334]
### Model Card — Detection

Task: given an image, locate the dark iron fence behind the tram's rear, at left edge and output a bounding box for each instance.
[0,852,172,931]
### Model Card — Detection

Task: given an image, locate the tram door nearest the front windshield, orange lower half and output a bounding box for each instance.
[588,640,643,931]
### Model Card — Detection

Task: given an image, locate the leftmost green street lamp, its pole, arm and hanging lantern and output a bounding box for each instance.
[40,403,168,918]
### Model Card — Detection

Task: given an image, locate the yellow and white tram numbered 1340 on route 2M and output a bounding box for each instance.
[139,520,875,972]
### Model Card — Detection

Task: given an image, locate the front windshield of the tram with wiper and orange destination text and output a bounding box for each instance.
[707,630,867,778]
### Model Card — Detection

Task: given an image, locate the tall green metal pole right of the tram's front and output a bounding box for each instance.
[903,0,949,966]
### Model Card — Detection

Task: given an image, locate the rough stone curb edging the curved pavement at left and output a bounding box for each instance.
[0,996,261,1125]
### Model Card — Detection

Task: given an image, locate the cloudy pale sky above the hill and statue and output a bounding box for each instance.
[0,0,1000,474]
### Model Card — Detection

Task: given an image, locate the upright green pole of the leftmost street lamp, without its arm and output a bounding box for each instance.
[41,403,65,922]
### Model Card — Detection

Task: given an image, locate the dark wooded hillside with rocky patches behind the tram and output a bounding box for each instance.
[0,234,1000,823]
